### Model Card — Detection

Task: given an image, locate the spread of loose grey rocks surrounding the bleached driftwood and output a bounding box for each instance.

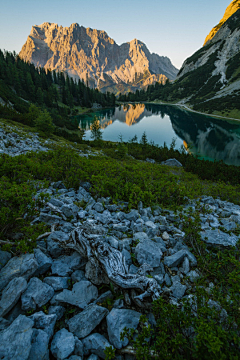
[0,182,240,360]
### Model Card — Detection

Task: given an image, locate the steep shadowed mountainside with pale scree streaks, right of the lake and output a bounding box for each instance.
[161,1,240,117]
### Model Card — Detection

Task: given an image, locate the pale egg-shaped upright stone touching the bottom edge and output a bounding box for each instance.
[51,328,75,360]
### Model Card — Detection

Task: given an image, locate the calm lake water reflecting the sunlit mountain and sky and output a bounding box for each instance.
[77,104,240,166]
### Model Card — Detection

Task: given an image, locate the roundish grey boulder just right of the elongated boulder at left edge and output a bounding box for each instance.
[21,278,54,311]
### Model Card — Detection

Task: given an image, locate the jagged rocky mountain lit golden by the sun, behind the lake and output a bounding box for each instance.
[19,22,178,93]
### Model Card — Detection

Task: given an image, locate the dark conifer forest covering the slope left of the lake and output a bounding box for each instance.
[0,50,115,142]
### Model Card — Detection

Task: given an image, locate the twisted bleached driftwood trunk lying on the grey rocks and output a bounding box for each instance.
[57,227,160,306]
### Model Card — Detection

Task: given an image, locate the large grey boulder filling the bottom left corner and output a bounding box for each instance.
[0,315,33,360]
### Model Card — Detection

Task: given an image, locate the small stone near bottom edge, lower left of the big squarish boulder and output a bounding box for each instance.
[82,333,111,359]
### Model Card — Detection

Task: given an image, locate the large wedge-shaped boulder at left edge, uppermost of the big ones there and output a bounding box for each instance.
[0,254,38,291]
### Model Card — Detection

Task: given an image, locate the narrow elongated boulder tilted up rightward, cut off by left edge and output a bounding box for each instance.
[0,277,27,316]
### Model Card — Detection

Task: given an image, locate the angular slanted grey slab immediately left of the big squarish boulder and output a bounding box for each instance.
[68,304,109,339]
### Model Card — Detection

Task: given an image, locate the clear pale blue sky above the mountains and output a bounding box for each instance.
[0,0,231,69]
